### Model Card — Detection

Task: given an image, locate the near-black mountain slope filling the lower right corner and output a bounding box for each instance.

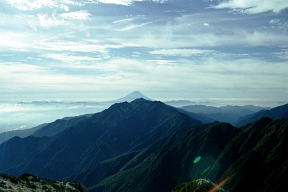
[208,118,288,192]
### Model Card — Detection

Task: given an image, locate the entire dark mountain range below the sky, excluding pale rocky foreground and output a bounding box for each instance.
[0,95,288,192]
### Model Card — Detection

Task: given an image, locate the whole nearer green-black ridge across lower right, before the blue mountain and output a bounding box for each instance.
[88,118,288,192]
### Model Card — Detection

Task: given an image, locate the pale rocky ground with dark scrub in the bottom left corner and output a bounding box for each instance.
[0,174,87,192]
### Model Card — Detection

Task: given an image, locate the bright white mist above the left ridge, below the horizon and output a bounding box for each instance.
[0,102,109,133]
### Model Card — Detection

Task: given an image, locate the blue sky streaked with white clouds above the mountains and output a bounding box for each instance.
[0,0,288,102]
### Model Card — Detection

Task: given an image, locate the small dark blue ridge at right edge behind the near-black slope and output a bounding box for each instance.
[237,104,288,125]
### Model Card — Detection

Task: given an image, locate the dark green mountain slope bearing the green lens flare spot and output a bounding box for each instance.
[91,123,238,192]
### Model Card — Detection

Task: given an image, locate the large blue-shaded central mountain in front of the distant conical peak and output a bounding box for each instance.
[0,99,200,179]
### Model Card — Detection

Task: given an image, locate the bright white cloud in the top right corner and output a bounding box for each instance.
[213,0,288,14]
